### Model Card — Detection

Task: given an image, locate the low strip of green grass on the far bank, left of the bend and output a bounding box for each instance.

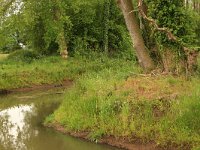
[0,56,117,90]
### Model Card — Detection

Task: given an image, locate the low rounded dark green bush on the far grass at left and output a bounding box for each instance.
[8,50,41,63]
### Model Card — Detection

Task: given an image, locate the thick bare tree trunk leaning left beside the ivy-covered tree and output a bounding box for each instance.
[117,0,155,71]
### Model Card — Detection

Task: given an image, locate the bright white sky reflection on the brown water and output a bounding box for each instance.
[0,104,34,150]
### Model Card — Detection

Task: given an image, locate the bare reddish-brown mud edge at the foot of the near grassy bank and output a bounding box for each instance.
[46,124,161,150]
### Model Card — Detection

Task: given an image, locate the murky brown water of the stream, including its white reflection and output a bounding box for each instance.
[0,89,119,150]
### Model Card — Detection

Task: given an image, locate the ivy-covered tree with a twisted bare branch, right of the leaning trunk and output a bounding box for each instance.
[145,0,199,74]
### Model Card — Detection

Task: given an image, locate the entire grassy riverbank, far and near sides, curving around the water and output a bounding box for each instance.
[0,56,200,149]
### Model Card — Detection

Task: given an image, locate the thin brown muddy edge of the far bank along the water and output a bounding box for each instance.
[0,80,73,95]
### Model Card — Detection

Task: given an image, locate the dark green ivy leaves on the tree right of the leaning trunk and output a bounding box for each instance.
[146,0,199,49]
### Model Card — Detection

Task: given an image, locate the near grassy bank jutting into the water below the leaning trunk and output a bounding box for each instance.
[45,56,200,149]
